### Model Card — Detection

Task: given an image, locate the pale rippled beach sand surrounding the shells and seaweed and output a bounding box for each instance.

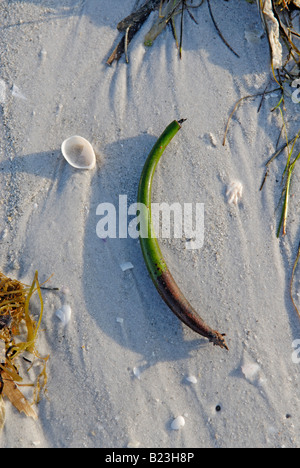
[0,0,300,448]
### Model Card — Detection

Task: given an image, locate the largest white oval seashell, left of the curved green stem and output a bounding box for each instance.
[61,135,96,169]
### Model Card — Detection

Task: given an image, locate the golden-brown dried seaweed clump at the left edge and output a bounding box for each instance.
[0,272,49,430]
